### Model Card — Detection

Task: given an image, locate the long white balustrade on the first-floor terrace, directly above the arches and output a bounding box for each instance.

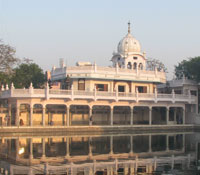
[0,88,196,103]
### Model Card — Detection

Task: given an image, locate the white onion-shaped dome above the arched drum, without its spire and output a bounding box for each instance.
[117,33,141,54]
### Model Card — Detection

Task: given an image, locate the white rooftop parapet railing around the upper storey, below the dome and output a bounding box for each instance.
[51,65,166,83]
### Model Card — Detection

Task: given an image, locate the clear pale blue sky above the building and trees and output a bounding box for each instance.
[0,0,200,79]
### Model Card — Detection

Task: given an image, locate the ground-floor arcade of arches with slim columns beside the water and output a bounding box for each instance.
[1,104,185,126]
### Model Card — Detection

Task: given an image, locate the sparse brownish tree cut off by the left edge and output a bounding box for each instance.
[0,40,19,74]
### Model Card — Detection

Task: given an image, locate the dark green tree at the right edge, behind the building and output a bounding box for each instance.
[175,56,200,82]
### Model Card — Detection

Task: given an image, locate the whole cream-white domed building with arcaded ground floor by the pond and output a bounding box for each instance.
[0,23,196,127]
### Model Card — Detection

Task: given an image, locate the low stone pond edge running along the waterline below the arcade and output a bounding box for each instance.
[0,124,200,136]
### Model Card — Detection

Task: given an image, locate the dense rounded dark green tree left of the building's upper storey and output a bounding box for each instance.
[12,63,46,88]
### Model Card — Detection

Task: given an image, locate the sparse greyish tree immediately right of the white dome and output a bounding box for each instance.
[146,58,167,72]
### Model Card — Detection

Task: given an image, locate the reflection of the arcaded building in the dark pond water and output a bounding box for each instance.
[0,133,200,175]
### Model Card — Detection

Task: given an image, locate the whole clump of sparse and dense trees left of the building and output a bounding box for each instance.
[0,40,45,88]
